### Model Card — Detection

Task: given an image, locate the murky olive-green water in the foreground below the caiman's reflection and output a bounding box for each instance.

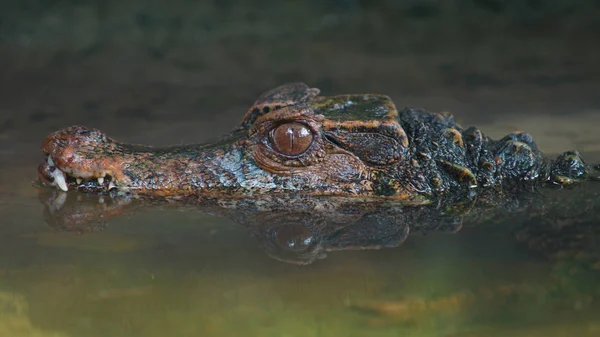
[0,139,600,337]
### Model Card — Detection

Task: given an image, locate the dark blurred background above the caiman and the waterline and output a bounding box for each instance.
[0,0,600,160]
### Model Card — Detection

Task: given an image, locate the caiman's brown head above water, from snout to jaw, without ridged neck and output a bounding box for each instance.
[39,83,416,200]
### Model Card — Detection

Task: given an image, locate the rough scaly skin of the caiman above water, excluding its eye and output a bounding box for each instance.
[39,83,592,204]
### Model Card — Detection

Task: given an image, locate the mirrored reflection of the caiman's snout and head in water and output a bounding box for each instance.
[39,188,472,265]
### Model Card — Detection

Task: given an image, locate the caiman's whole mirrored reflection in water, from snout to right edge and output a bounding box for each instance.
[38,184,600,268]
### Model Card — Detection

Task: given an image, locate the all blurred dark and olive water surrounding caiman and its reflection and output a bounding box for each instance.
[0,1,600,337]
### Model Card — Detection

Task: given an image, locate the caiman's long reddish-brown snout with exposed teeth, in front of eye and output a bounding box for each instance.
[38,125,260,197]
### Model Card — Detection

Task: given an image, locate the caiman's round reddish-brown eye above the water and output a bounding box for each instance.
[270,122,314,156]
